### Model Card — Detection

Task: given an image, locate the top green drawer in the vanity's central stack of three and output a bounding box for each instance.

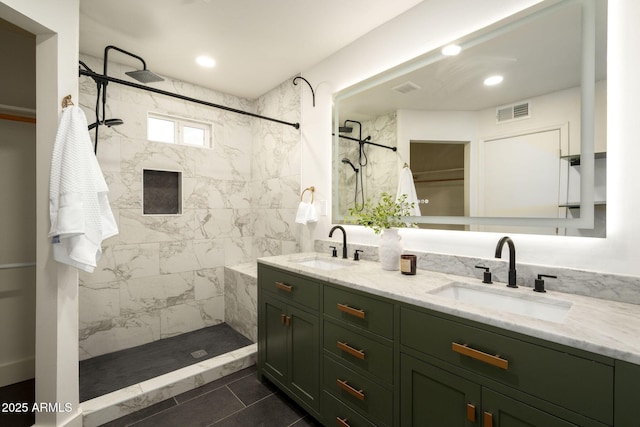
[324,286,393,339]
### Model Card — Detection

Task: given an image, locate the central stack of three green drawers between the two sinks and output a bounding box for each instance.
[322,284,398,427]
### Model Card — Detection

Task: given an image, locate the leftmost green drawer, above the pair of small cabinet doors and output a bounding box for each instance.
[258,264,320,310]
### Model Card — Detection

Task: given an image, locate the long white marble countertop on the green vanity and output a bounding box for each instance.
[258,252,640,364]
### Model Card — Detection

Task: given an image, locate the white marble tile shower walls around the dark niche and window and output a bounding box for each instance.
[79,56,300,359]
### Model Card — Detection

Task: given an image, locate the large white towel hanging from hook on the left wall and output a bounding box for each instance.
[49,106,118,273]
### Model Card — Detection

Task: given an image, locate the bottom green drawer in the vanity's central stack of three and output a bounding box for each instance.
[323,356,393,425]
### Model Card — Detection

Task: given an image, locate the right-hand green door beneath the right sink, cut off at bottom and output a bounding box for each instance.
[482,388,577,427]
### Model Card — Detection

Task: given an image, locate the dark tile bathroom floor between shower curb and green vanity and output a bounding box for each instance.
[103,366,321,427]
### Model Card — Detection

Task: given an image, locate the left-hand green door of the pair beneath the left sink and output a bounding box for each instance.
[261,296,288,384]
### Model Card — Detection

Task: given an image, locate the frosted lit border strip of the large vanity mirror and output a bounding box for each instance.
[331,0,596,229]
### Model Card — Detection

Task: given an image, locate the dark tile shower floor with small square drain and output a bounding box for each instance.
[80,323,252,402]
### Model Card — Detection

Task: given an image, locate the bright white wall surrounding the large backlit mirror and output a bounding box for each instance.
[301,0,640,276]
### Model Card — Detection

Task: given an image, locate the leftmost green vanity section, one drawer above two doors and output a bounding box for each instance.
[258,267,320,417]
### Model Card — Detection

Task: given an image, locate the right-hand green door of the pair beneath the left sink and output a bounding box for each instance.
[286,307,320,409]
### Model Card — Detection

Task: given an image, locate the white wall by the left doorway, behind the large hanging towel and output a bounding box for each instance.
[0,0,82,426]
